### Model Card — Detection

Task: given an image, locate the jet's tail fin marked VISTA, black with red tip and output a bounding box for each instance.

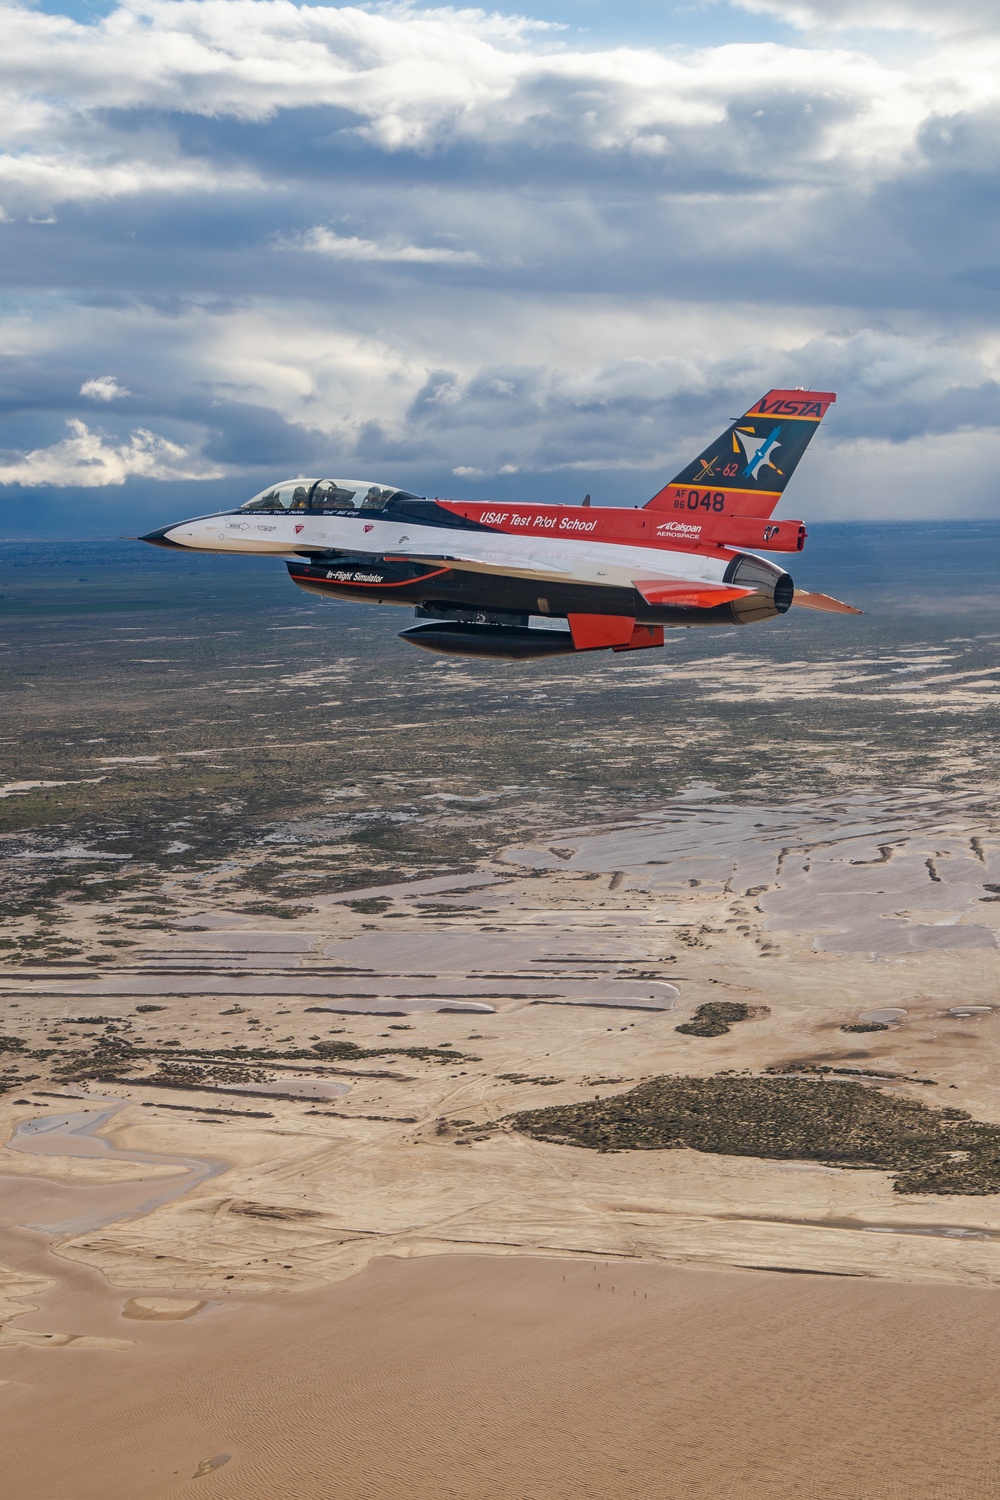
[646,390,837,518]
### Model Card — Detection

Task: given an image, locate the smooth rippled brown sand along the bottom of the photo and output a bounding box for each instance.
[0,1257,1000,1500]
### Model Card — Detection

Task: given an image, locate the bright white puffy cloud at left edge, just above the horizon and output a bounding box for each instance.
[0,419,222,489]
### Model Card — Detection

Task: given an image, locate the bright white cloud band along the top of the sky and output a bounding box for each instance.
[0,0,983,222]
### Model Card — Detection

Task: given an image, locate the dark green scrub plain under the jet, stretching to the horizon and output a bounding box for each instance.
[0,542,996,918]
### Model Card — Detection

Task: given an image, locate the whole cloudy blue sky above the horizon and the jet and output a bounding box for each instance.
[0,0,1000,539]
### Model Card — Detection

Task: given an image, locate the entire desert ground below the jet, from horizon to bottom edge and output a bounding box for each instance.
[0,534,1000,1500]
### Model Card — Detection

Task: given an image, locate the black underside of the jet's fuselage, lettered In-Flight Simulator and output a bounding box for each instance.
[286,554,758,626]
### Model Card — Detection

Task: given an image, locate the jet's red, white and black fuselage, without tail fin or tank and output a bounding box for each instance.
[144,479,804,626]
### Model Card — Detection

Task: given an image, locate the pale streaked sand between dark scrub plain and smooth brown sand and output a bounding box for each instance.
[0,791,1000,1296]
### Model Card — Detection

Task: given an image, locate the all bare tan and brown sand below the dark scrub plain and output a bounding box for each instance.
[0,794,1000,1500]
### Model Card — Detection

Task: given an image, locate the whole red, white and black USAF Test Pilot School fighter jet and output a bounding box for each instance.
[141,390,861,659]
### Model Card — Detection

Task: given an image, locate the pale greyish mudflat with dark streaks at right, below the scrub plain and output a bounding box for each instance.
[508,791,1000,956]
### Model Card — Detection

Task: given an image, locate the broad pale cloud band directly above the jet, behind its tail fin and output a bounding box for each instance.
[7,287,1000,519]
